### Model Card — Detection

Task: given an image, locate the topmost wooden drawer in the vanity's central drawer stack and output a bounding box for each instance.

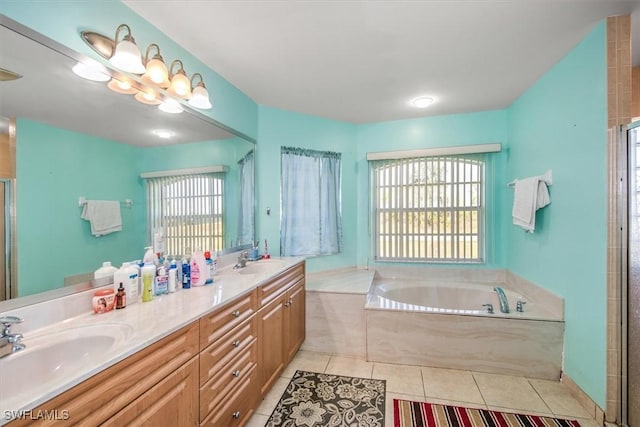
[200,290,257,350]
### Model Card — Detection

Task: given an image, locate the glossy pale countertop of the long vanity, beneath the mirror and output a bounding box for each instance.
[0,254,303,425]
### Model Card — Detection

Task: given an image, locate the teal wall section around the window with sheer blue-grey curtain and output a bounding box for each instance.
[256,106,358,271]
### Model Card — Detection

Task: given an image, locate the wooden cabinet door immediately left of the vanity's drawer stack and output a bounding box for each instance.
[102,357,199,427]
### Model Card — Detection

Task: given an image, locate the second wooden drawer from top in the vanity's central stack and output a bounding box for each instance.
[200,316,258,386]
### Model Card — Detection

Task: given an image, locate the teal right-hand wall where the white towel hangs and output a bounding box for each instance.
[504,22,607,408]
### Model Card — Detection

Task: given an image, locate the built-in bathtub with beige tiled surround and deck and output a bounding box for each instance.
[302,266,564,380]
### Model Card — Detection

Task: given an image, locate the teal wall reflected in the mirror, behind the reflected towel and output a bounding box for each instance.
[16,119,145,296]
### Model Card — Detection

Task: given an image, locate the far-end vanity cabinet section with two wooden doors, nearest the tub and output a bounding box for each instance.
[258,262,305,397]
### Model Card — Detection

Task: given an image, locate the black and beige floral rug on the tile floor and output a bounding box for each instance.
[266,371,386,427]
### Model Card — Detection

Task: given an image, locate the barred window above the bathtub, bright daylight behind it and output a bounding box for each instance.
[370,155,485,262]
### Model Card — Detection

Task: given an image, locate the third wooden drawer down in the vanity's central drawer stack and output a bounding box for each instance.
[200,341,258,420]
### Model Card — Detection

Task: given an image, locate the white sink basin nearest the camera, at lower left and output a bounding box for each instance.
[0,323,133,401]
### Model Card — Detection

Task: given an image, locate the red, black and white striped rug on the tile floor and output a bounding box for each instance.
[393,399,580,427]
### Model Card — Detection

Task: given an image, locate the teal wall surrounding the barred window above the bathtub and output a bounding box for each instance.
[356,110,507,268]
